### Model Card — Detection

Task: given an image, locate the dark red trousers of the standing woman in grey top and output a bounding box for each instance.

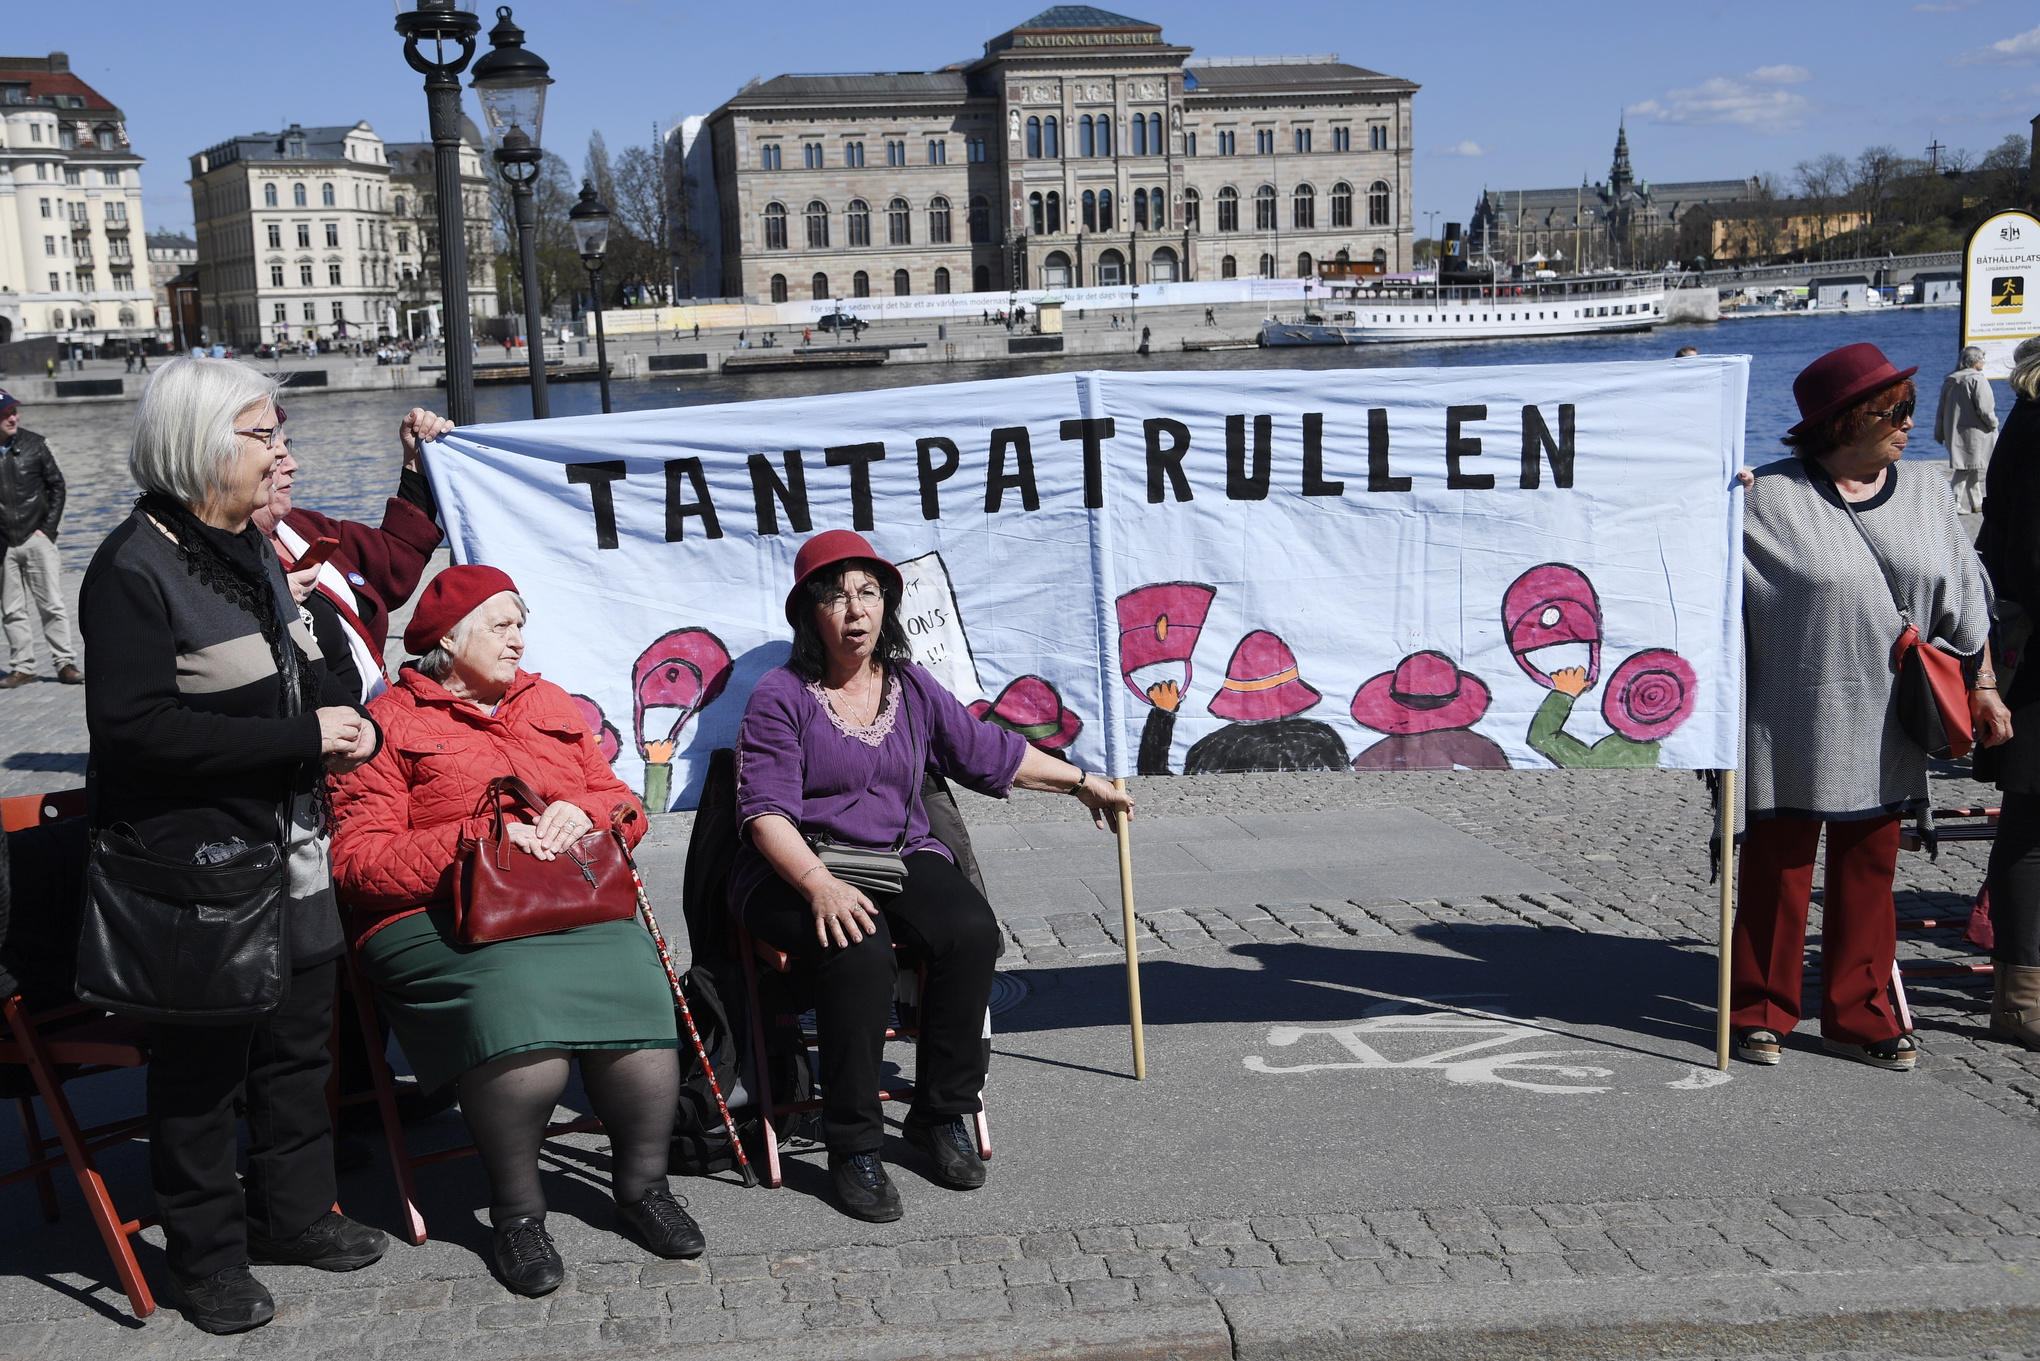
[1728,814,1905,1045]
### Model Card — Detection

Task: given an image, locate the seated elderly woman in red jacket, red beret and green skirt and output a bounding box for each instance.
[333,567,704,1296]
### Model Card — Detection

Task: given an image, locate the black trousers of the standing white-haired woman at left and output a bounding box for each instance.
[149,959,339,1275]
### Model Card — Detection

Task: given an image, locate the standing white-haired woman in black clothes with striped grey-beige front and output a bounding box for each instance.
[80,359,388,1332]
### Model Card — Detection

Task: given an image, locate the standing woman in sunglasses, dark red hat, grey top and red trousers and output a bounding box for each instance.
[1730,345,2011,1071]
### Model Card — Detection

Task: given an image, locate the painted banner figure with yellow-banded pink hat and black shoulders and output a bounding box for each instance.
[1183,628,1348,775]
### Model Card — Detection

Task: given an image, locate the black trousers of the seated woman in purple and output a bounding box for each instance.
[745,851,1000,1157]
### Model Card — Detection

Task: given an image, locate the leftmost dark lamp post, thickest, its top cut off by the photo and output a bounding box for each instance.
[396,0,481,424]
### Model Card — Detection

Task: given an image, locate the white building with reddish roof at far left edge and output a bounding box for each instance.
[0,51,155,343]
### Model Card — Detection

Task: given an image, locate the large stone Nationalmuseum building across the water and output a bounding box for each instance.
[683,4,1416,302]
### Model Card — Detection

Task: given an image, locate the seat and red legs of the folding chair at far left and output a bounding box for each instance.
[0,991,155,1318]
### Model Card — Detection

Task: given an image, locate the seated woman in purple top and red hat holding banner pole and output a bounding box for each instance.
[730,531,1132,1222]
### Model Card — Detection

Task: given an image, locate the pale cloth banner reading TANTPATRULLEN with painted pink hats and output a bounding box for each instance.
[428,357,1748,808]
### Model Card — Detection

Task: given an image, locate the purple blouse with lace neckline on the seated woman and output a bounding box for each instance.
[730,663,1026,910]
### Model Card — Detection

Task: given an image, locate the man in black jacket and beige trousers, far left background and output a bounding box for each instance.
[0,392,86,690]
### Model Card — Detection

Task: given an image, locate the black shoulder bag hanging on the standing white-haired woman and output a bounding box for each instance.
[78,828,290,1026]
